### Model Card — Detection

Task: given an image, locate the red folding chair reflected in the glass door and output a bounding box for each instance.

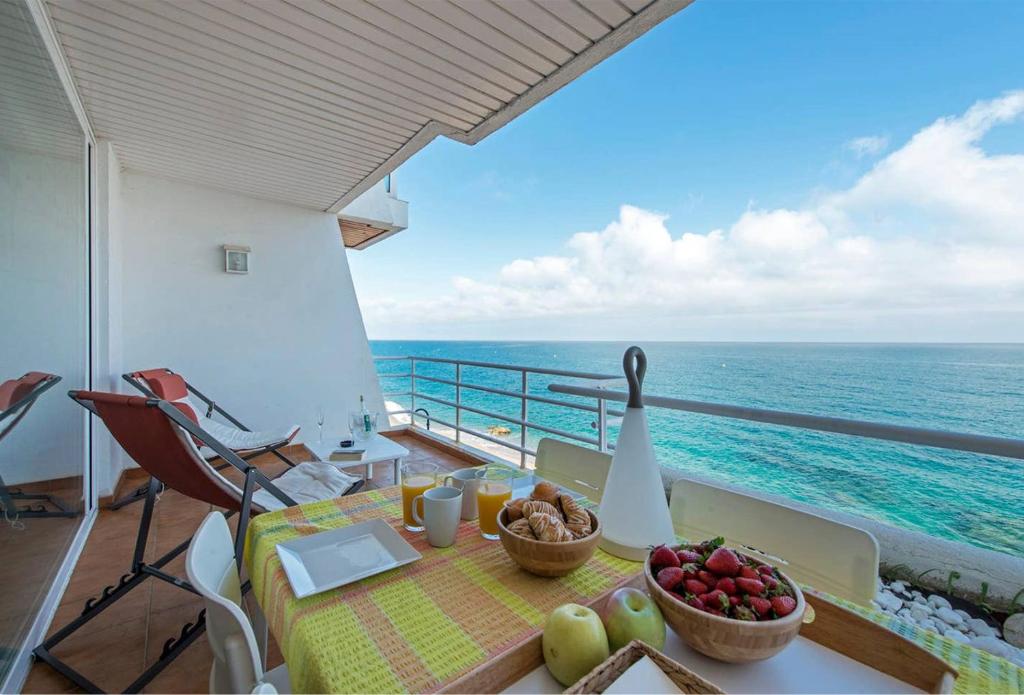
[0,372,78,523]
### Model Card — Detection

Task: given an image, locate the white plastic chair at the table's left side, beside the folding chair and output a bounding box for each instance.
[185,512,290,693]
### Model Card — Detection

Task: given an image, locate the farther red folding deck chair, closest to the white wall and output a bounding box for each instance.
[110,368,299,509]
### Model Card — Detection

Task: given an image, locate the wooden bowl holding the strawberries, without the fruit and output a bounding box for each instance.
[643,547,807,663]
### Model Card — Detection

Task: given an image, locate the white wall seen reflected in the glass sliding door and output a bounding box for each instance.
[0,147,88,485]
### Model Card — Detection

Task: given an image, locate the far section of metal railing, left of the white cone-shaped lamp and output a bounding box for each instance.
[374,355,624,467]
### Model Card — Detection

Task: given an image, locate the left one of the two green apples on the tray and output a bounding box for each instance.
[541,603,610,686]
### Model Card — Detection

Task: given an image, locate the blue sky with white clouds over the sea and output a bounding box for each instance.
[349,0,1024,340]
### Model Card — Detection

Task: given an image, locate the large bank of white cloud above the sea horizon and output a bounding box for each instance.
[364,91,1024,340]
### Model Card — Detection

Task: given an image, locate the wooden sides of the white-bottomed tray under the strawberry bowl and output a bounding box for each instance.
[440,574,956,693]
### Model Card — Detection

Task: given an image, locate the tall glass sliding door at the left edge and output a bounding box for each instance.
[0,0,89,683]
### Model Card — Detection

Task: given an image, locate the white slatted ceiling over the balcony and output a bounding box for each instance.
[46,0,692,212]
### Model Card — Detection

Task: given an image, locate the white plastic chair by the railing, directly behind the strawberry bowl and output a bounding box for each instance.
[669,479,879,606]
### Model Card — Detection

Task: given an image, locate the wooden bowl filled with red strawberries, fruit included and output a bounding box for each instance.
[644,538,806,663]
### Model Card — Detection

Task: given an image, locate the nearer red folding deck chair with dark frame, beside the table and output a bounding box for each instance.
[34,391,362,692]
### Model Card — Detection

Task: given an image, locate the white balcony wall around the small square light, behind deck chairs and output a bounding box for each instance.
[97,171,384,494]
